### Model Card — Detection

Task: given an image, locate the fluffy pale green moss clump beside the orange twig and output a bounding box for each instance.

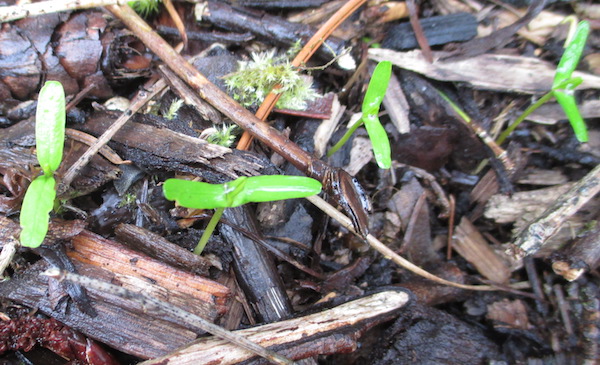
[225,50,320,110]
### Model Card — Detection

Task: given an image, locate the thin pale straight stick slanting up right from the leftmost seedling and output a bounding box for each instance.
[58,76,167,194]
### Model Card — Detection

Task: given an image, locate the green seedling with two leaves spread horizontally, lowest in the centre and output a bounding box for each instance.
[163,175,321,255]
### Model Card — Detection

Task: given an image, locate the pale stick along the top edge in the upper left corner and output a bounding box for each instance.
[0,0,128,23]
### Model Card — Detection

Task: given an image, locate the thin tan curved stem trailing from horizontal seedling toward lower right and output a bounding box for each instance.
[306,195,528,291]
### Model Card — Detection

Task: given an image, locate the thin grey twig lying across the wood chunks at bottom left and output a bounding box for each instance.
[42,267,294,365]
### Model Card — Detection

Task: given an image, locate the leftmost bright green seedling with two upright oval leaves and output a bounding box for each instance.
[19,81,65,248]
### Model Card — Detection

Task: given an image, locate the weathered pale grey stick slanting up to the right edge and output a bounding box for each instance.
[511,165,600,258]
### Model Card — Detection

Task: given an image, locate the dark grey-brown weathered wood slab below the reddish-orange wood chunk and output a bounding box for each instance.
[0,260,197,359]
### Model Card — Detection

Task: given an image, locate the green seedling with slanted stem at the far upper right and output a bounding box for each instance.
[496,21,590,144]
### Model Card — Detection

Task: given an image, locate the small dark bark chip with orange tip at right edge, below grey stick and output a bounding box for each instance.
[552,226,600,281]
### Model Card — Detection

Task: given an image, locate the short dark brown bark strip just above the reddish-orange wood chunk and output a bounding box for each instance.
[115,224,211,276]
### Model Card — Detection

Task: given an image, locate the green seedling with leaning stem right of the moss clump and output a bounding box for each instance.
[327,61,392,169]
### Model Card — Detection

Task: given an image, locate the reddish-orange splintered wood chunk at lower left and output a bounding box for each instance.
[67,231,229,318]
